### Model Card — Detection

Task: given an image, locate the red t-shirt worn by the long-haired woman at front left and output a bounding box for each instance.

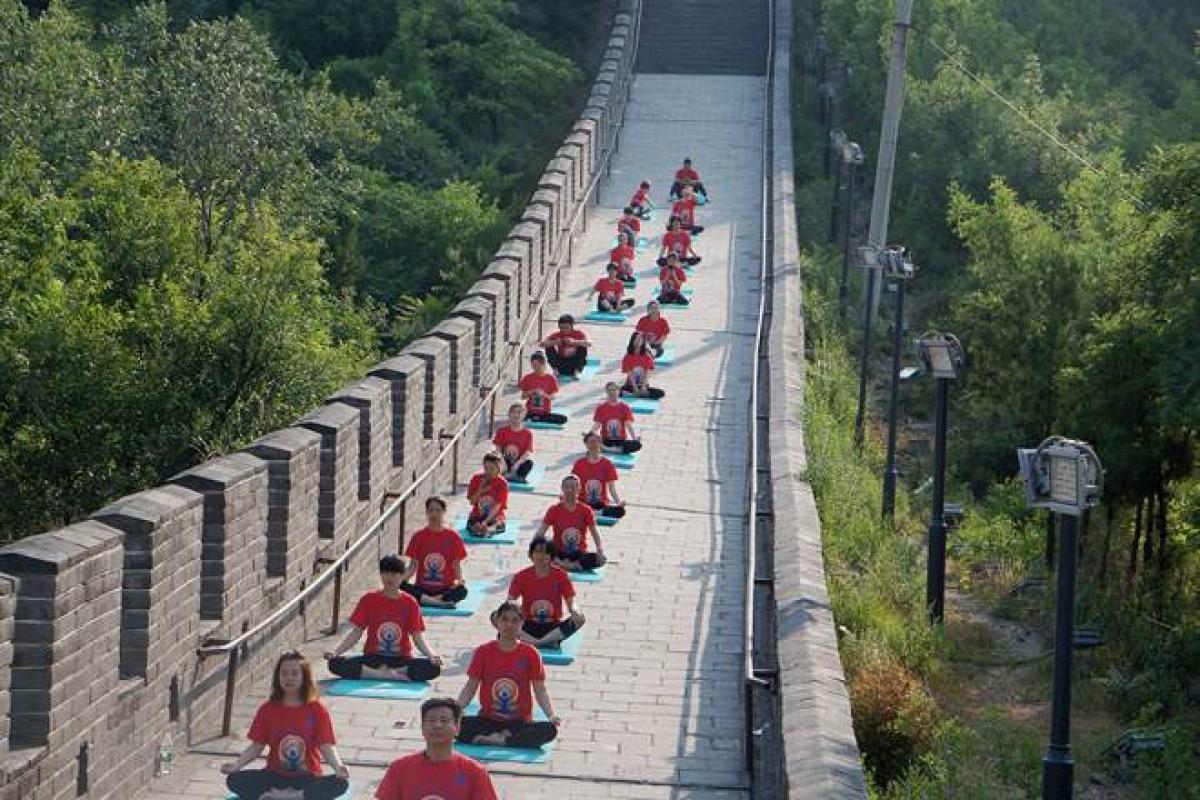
[246,700,336,777]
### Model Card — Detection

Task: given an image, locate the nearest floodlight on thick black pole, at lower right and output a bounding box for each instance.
[1016,437,1104,800]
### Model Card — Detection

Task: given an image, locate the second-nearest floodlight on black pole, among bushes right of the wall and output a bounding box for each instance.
[917,333,966,625]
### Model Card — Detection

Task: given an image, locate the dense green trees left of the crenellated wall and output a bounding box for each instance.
[0,0,608,539]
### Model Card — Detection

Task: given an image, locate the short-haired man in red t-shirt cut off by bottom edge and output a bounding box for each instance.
[376,697,497,800]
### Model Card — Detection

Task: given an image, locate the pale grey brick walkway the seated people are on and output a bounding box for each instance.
[149,74,762,800]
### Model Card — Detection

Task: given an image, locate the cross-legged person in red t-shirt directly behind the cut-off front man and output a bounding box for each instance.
[458,600,563,747]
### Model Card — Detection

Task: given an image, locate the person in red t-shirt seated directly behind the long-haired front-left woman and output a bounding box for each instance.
[325,555,443,680]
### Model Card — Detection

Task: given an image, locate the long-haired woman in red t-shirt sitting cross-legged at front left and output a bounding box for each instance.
[221,650,350,800]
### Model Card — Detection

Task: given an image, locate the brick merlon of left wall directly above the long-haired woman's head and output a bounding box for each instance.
[246,428,320,595]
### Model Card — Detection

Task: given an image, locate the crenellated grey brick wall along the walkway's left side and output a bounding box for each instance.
[0,0,641,800]
